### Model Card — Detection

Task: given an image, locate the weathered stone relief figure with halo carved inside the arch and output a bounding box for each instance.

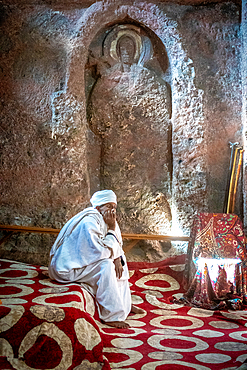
[87,24,172,260]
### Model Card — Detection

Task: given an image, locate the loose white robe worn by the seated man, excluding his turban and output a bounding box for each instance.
[49,207,131,322]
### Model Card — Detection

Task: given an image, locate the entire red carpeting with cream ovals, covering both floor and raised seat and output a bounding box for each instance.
[0,256,247,370]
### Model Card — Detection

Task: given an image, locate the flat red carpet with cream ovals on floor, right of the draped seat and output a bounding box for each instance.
[99,258,247,370]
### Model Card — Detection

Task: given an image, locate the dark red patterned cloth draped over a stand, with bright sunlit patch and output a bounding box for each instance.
[180,213,247,310]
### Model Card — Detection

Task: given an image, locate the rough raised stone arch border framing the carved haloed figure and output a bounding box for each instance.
[52,1,207,257]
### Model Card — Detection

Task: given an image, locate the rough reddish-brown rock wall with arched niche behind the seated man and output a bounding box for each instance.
[0,1,243,263]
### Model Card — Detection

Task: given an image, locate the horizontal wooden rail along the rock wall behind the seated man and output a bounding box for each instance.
[0,225,190,252]
